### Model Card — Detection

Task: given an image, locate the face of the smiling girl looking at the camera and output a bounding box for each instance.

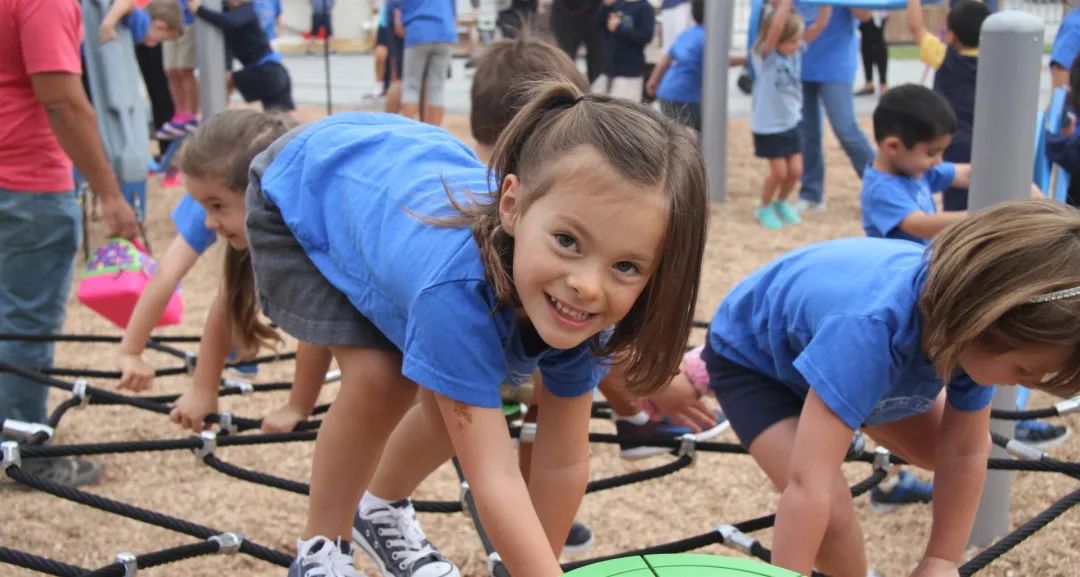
[499,147,667,349]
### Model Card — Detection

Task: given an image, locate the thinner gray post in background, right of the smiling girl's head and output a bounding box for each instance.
[701,0,734,202]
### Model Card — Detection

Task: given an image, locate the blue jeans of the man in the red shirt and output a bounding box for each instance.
[0,189,81,438]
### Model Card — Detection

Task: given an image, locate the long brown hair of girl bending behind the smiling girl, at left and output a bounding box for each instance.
[179,106,293,357]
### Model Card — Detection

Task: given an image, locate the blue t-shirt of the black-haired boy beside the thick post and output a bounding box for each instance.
[860,162,956,244]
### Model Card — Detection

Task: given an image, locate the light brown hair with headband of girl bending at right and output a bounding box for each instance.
[919,200,1080,397]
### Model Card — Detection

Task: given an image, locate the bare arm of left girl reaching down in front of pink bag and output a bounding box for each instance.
[118,236,199,391]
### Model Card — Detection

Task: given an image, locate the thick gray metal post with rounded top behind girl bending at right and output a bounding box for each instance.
[969,10,1043,547]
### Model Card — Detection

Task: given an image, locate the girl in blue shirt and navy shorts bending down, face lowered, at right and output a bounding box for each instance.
[703,200,1080,577]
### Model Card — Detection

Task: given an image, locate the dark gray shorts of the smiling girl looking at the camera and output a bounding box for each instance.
[245,126,397,350]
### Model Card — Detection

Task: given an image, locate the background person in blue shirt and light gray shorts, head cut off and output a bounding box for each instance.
[401,0,458,126]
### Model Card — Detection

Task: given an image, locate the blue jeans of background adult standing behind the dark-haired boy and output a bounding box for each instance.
[799,82,874,202]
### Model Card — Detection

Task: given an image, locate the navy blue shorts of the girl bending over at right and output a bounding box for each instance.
[701,343,806,449]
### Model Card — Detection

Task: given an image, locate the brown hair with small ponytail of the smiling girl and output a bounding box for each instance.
[443,80,708,394]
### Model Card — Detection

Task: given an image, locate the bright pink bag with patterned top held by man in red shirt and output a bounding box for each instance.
[79,239,184,328]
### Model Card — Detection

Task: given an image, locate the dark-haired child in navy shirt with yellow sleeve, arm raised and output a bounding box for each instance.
[907,0,990,211]
